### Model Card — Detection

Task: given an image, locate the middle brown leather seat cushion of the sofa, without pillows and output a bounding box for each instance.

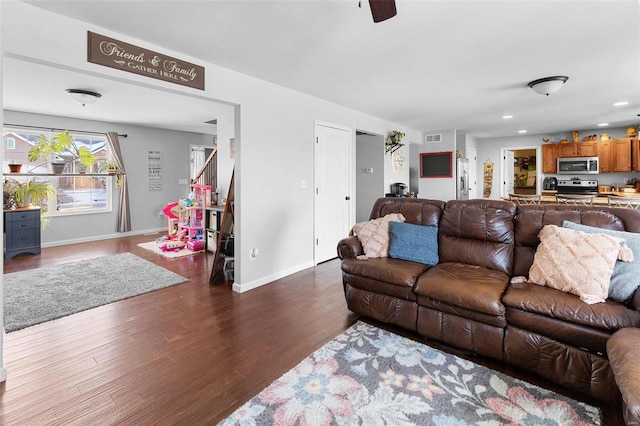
[414,262,509,316]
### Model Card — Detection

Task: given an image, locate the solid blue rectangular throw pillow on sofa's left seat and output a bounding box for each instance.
[389,222,438,265]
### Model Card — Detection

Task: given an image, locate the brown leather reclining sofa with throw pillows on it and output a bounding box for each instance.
[338,198,640,404]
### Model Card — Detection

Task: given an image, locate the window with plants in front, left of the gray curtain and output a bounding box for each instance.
[3,129,113,216]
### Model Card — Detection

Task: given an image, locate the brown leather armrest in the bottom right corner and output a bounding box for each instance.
[607,328,640,425]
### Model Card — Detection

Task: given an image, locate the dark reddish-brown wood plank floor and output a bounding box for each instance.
[0,236,622,426]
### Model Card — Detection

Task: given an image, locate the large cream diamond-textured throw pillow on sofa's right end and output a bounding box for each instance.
[529,225,621,304]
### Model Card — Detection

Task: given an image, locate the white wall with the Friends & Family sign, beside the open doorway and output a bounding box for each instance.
[1,2,421,291]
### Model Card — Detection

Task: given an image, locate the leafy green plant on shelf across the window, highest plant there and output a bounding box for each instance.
[27,130,95,173]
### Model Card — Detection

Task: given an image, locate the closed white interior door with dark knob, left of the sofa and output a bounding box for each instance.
[314,124,351,264]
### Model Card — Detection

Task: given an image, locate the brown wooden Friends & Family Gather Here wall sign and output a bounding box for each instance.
[87,31,204,90]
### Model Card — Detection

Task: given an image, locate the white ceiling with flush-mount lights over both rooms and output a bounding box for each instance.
[4,0,640,139]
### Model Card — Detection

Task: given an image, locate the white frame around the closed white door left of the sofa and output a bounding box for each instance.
[312,120,356,265]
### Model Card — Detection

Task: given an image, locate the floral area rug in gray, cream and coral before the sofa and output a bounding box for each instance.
[220,322,600,426]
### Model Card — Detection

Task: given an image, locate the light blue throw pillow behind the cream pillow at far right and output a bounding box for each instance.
[562,220,640,302]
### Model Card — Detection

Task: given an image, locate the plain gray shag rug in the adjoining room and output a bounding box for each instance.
[3,253,188,333]
